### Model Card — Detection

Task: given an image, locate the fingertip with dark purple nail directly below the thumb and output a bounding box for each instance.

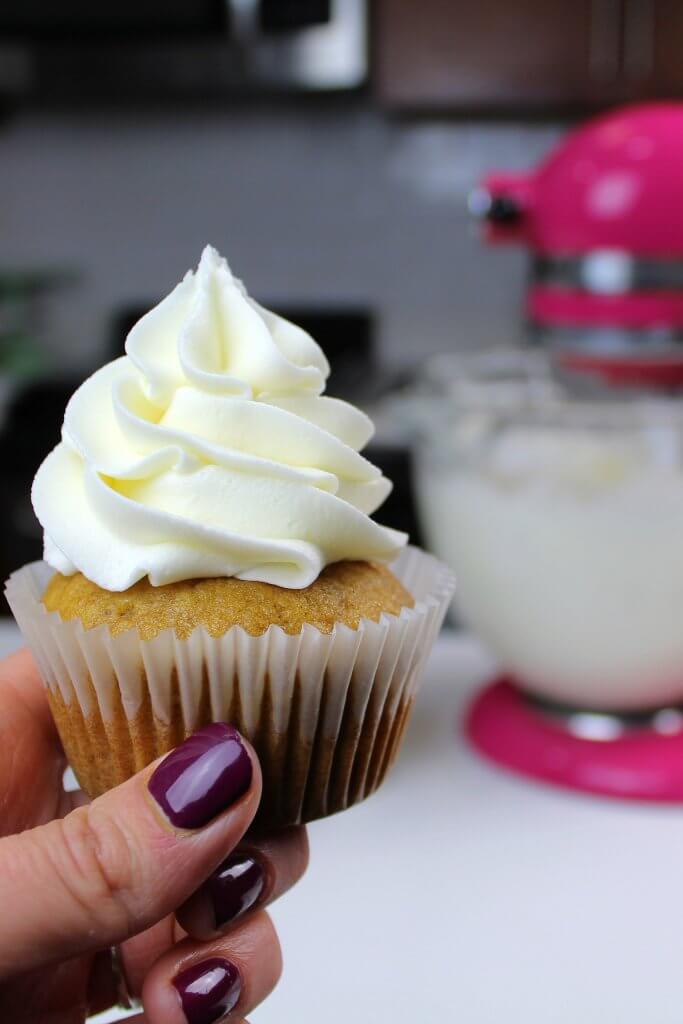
[176,828,308,940]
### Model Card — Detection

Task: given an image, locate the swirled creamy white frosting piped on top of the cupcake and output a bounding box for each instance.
[32,242,405,591]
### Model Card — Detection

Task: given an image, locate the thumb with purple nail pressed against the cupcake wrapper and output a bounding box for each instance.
[0,723,261,981]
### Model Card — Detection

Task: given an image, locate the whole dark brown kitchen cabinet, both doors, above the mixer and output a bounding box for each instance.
[374,0,683,112]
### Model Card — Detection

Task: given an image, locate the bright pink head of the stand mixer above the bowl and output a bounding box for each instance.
[470,102,683,387]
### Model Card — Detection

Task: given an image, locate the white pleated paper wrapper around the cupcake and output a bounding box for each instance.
[6,548,455,826]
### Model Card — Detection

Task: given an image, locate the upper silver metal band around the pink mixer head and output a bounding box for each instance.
[532,249,683,295]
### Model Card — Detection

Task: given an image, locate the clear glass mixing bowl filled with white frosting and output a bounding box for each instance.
[415,387,683,711]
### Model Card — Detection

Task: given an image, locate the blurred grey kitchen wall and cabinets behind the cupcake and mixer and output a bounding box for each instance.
[0,0,683,589]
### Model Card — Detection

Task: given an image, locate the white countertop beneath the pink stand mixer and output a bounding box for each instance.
[0,630,683,1024]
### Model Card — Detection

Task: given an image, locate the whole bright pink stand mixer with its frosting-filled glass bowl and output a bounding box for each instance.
[458,103,683,802]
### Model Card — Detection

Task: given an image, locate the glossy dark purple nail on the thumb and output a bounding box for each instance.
[148,722,253,828]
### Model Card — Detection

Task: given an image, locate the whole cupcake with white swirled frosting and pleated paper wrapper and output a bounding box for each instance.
[6,248,453,827]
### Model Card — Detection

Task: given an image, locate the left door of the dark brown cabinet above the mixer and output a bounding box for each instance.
[374,0,626,110]
